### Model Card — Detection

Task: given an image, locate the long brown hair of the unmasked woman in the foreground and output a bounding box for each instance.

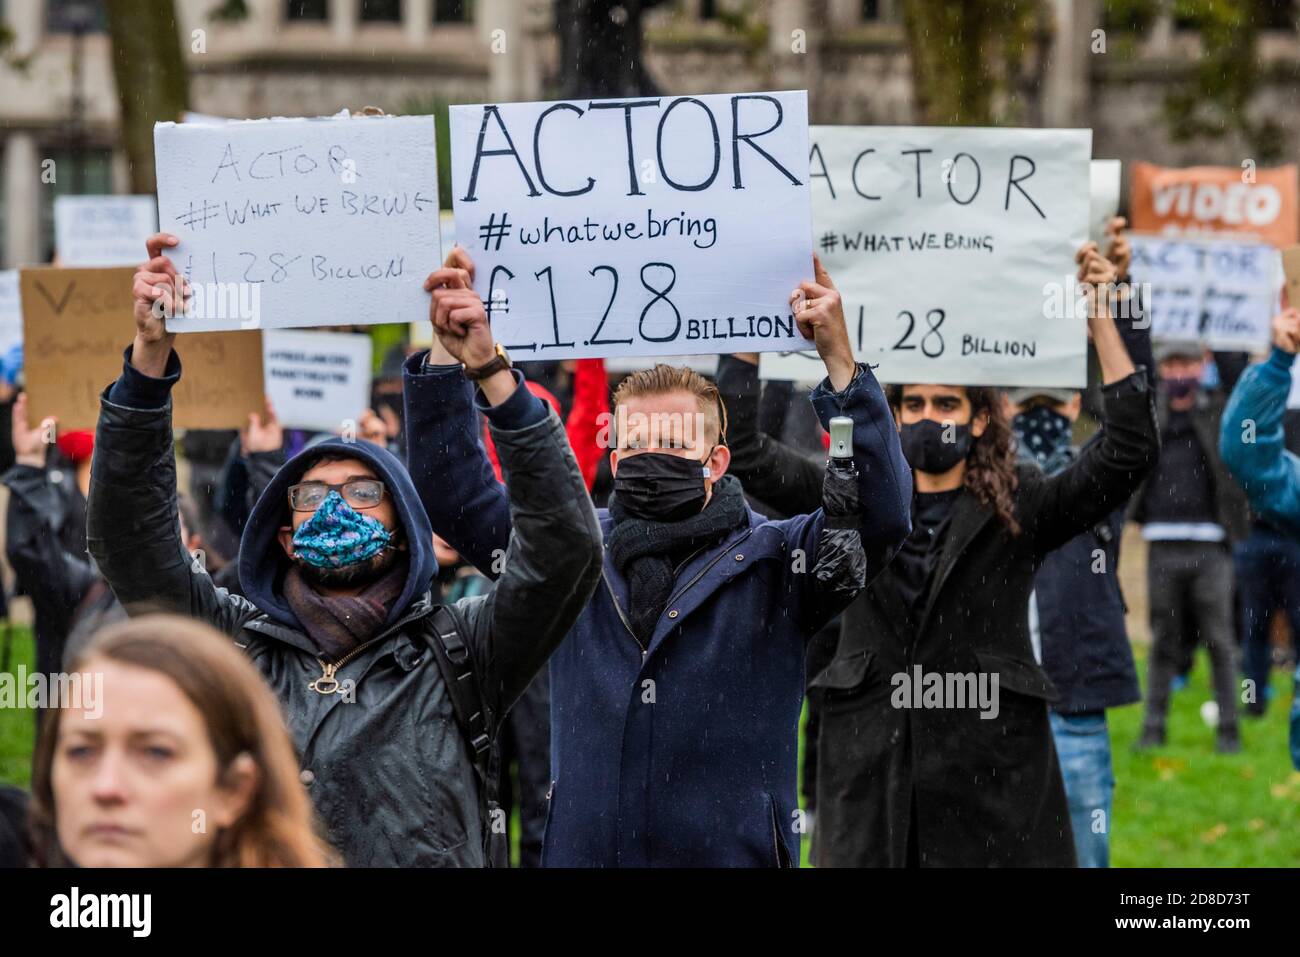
[29,615,337,867]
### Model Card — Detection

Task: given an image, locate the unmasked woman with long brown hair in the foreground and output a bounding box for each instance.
[29,615,334,867]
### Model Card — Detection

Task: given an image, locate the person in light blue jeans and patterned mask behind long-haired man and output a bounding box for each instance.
[1006,217,1156,867]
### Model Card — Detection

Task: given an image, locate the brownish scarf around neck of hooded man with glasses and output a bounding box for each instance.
[283,558,407,662]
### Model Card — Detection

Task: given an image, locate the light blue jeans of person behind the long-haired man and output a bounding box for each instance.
[1050,711,1115,867]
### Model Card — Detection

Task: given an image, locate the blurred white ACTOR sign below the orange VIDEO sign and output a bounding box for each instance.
[1128,235,1282,351]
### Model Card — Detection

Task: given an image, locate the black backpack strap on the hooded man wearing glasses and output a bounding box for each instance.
[426,605,508,867]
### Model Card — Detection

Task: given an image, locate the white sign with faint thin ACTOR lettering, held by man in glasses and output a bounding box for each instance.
[153,116,439,332]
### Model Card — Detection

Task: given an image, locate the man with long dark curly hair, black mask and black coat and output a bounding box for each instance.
[719,243,1157,867]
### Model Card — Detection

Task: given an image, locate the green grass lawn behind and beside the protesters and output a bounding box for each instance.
[0,629,1300,867]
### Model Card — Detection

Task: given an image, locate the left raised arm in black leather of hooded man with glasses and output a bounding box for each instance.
[86,234,256,635]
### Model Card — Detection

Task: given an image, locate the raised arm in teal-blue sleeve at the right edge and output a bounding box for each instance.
[1219,308,1300,537]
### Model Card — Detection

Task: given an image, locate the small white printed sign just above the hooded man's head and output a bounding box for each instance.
[263,330,371,432]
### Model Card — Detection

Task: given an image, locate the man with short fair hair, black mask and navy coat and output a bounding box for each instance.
[407,251,911,867]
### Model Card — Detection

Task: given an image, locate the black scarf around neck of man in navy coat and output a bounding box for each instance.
[606,475,746,645]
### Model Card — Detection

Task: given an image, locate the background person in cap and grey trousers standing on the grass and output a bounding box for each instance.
[1131,342,1248,754]
